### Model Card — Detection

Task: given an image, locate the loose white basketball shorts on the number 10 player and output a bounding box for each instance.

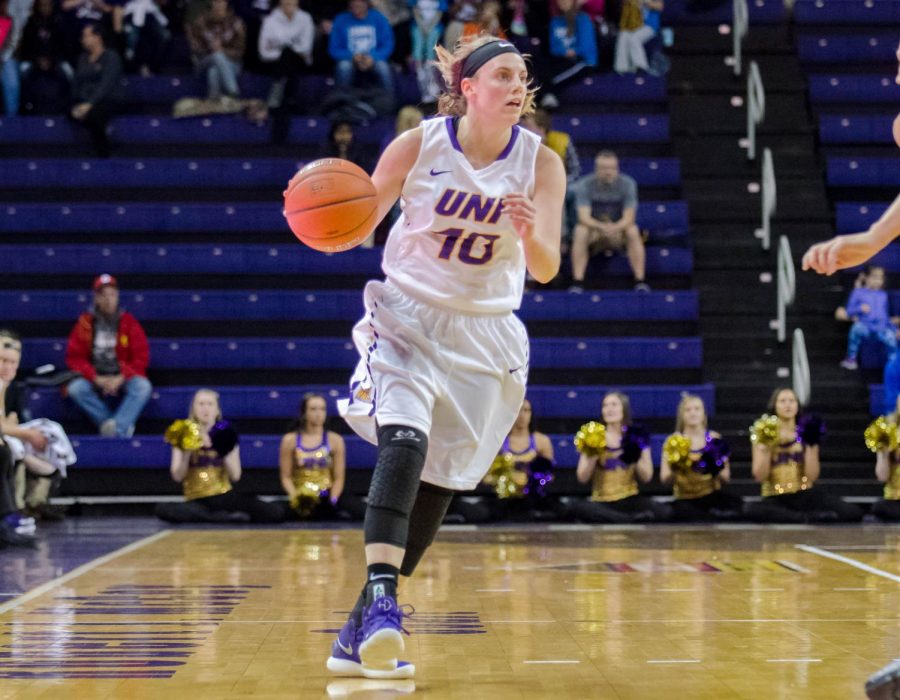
[338,282,528,490]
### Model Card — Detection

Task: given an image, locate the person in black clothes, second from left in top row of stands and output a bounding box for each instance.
[18,0,75,114]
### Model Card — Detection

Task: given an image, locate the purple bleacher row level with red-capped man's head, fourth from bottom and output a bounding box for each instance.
[0,291,698,323]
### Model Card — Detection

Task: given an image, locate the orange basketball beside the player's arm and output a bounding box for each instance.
[284,158,378,253]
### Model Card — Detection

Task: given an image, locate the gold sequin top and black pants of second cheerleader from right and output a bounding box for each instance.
[747,438,862,523]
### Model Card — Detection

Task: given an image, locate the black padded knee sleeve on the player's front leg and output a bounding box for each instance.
[363,425,428,547]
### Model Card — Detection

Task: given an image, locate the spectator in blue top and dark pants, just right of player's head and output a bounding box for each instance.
[536,0,598,109]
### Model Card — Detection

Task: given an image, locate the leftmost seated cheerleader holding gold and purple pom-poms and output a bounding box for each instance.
[156,389,283,523]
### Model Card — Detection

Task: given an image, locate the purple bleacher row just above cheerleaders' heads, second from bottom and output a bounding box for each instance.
[28,384,715,422]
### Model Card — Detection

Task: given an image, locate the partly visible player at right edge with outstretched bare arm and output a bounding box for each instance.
[803,46,900,700]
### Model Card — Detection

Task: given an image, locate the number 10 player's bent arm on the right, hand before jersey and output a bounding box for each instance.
[503,146,566,284]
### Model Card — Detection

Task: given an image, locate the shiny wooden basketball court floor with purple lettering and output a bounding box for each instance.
[0,519,900,700]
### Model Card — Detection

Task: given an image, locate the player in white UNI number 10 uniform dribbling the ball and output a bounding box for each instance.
[328,36,566,678]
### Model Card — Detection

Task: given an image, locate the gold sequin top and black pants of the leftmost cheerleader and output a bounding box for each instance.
[156,447,282,523]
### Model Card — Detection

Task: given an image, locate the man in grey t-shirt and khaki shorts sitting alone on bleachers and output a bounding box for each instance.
[569,151,650,293]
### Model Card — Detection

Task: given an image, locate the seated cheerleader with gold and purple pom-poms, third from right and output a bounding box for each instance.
[659,394,743,521]
